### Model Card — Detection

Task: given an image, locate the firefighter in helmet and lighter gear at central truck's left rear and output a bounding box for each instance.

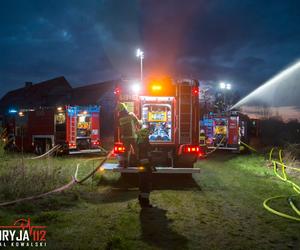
[117,103,141,167]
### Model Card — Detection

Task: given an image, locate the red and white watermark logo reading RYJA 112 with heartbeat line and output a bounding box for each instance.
[0,218,47,248]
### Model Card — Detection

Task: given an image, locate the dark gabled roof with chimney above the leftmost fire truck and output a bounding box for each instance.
[0,77,72,113]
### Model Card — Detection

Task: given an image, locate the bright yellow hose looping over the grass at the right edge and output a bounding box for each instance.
[263,148,300,221]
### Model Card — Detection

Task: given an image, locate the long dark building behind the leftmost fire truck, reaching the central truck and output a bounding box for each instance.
[0,77,119,139]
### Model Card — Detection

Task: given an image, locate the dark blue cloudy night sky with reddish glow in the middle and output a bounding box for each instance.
[0,0,300,97]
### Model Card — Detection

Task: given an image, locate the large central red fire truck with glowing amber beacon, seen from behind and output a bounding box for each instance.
[114,78,203,174]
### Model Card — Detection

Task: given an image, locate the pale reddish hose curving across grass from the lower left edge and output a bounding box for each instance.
[0,150,113,207]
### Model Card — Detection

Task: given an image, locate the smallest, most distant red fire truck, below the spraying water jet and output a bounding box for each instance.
[200,111,250,152]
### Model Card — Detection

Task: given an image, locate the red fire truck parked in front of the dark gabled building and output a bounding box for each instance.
[4,106,101,155]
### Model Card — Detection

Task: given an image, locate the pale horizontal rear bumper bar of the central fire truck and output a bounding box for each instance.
[101,163,200,174]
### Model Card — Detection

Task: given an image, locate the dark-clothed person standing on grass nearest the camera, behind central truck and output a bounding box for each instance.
[137,128,154,208]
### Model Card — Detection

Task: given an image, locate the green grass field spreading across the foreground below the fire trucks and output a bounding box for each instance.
[0,151,300,249]
